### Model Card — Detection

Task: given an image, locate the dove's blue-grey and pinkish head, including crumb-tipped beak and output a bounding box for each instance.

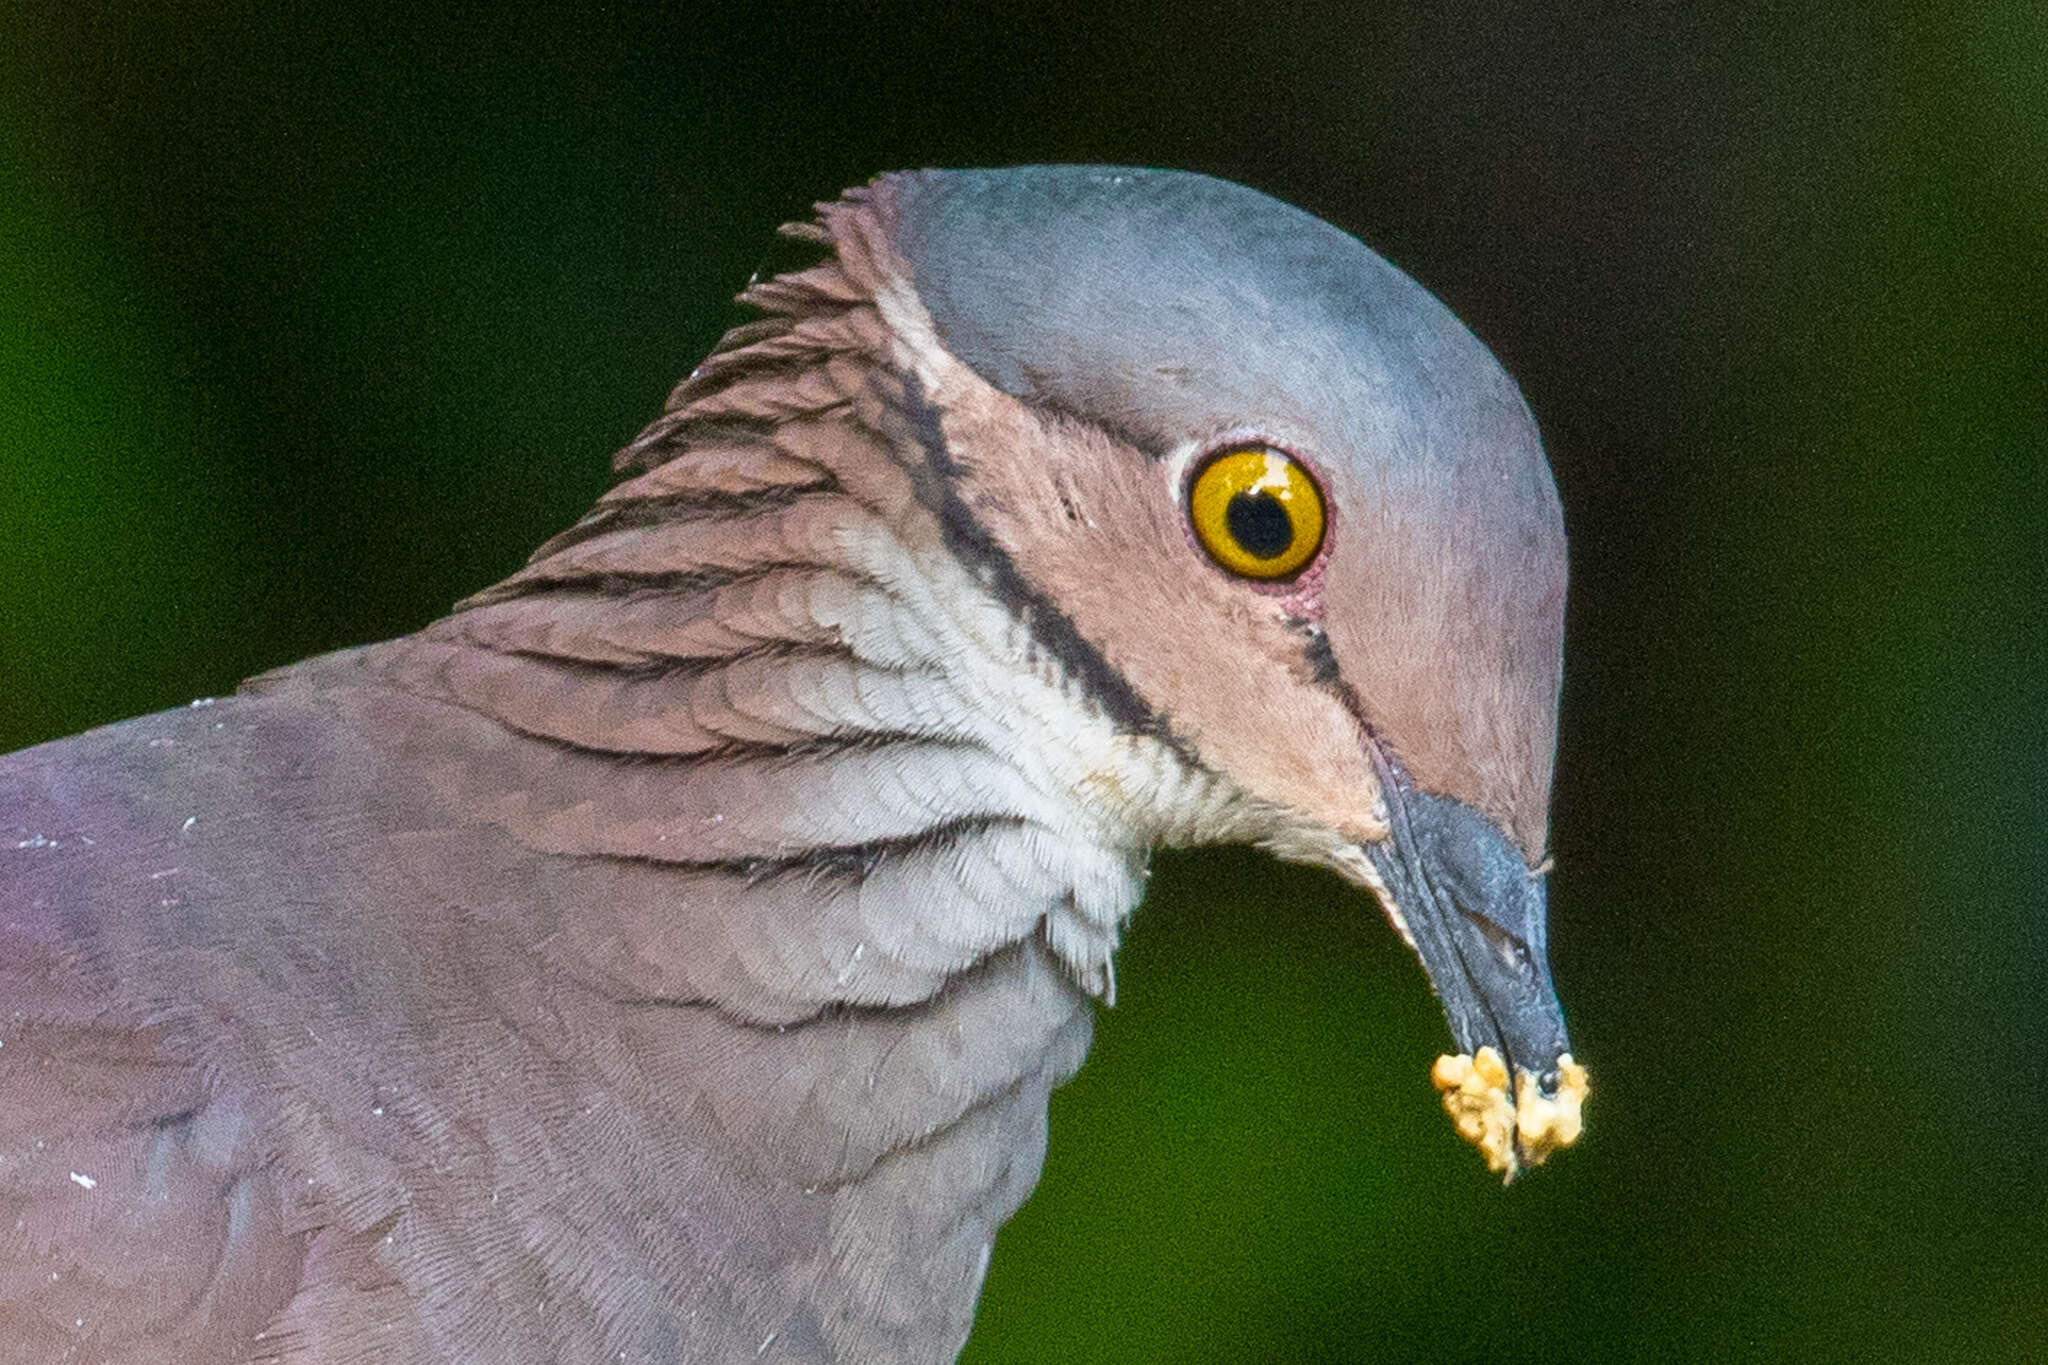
[843,168,1585,1177]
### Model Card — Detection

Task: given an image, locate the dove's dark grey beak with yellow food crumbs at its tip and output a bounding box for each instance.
[1348,772,1587,1181]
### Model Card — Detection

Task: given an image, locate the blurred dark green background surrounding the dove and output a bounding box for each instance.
[0,0,2048,1363]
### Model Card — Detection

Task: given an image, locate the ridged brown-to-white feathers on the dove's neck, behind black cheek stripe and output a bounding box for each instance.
[354,239,1253,1023]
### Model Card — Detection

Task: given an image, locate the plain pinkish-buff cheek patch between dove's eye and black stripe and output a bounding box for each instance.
[892,341,1386,843]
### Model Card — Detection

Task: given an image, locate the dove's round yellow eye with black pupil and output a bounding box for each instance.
[1188,446,1323,579]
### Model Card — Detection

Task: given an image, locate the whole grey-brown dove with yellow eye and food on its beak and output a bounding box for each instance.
[0,166,1589,1365]
